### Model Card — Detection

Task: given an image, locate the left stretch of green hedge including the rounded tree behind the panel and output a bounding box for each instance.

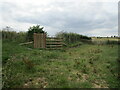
[0,25,47,43]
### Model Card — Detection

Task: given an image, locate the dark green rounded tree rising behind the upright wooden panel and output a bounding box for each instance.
[27,25,46,41]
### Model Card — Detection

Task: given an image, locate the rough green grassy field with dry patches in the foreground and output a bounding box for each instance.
[2,41,120,88]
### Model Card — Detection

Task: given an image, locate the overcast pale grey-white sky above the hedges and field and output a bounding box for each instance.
[0,0,119,36]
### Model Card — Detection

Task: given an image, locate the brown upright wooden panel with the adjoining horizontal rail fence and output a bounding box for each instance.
[34,33,63,49]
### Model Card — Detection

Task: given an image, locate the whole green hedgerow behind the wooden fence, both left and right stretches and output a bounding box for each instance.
[0,25,91,43]
